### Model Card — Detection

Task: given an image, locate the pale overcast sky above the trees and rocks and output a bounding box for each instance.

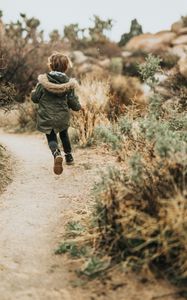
[0,0,187,41]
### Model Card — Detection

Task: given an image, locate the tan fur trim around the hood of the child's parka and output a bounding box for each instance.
[38,74,79,94]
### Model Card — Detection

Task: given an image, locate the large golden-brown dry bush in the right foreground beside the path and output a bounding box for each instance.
[97,158,187,283]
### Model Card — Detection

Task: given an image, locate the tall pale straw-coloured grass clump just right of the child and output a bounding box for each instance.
[72,75,109,146]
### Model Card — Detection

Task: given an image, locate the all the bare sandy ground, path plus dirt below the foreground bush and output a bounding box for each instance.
[0,132,184,300]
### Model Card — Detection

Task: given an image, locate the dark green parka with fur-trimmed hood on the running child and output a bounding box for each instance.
[31,71,81,134]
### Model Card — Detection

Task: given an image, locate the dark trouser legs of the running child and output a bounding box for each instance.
[46,129,71,154]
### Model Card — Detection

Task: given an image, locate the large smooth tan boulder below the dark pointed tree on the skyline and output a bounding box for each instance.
[125,31,176,52]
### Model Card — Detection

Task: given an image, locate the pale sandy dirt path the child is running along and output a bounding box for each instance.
[0,132,112,300]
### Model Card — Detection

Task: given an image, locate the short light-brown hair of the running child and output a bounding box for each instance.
[48,52,72,72]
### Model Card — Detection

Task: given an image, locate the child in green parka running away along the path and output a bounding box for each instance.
[31,52,81,175]
